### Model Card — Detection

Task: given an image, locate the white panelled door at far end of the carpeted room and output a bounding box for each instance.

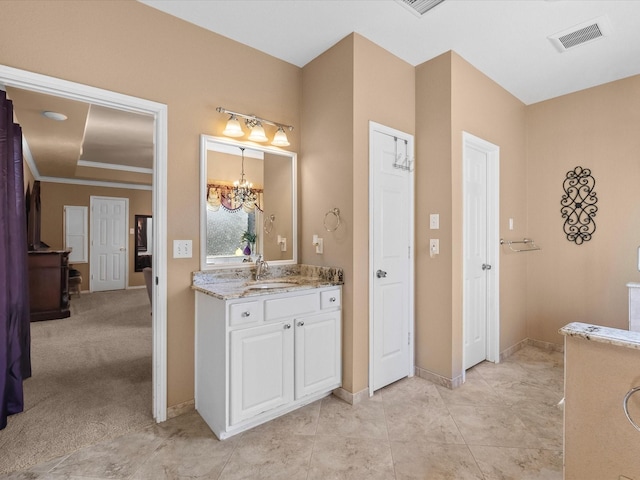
[90,197,129,292]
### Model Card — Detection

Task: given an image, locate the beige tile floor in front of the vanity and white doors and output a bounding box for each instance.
[3,346,563,480]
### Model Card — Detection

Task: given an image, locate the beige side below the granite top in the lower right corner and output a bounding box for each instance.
[564,336,640,480]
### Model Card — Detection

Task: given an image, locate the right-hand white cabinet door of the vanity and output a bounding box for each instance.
[295,311,342,400]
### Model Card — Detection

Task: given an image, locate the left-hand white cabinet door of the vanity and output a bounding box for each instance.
[229,321,293,425]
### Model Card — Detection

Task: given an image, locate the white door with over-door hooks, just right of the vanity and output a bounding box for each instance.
[369,123,413,393]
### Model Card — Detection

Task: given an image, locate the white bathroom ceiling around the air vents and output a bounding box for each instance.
[139,0,640,104]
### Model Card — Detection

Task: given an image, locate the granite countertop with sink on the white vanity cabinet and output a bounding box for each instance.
[191,265,344,300]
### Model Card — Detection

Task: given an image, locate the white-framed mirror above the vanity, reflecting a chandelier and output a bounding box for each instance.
[200,135,298,270]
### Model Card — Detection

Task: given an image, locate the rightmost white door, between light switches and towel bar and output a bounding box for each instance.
[463,134,498,370]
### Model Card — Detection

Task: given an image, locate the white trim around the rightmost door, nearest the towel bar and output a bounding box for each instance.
[462,131,500,368]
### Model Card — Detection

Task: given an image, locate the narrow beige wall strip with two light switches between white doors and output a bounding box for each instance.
[415,54,453,378]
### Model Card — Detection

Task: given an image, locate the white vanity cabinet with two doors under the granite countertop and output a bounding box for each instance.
[195,286,341,439]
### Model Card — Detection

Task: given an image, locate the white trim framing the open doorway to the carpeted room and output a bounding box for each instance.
[0,65,167,422]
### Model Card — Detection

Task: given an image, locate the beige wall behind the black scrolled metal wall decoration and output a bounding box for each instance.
[526,76,640,344]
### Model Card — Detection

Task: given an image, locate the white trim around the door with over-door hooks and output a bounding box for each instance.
[369,120,416,396]
